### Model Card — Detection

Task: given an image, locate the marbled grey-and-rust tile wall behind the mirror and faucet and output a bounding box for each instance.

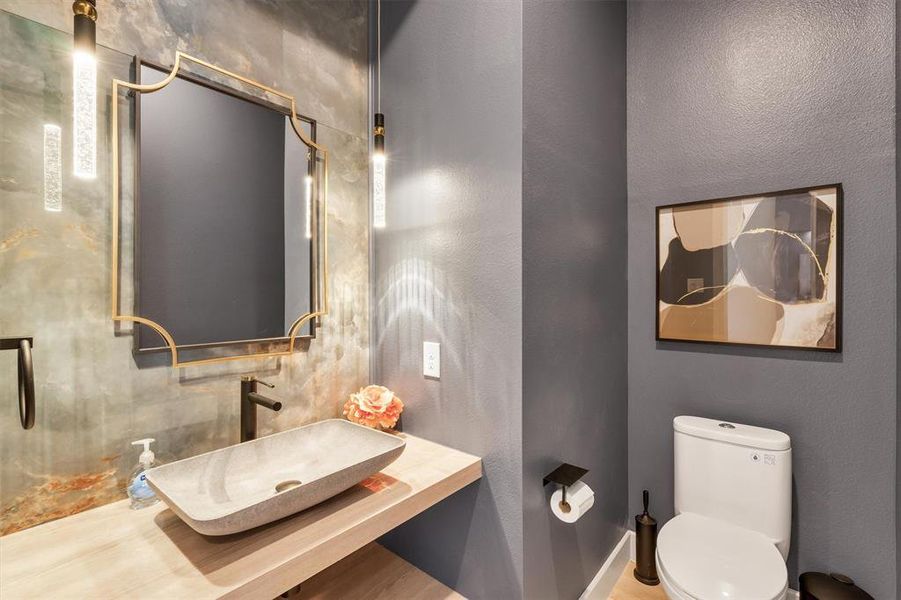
[0,0,369,535]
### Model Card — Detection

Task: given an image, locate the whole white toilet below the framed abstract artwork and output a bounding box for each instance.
[657,416,792,600]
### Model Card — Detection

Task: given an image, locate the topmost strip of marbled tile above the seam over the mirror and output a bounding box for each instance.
[0,0,368,137]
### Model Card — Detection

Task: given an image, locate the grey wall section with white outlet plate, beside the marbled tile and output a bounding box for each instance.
[372,0,522,599]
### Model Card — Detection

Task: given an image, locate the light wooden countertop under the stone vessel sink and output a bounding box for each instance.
[0,434,482,600]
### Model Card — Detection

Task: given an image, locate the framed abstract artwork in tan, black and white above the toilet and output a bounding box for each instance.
[656,184,842,352]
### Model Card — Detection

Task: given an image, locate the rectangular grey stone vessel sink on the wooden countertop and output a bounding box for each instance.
[147,419,406,535]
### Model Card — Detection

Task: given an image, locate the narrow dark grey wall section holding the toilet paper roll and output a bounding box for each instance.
[523,0,628,599]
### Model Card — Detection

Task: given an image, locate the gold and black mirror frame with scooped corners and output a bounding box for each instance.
[110,51,329,368]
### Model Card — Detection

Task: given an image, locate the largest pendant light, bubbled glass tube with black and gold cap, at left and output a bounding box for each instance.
[72,0,97,179]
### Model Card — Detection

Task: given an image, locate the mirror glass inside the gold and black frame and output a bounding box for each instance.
[134,61,317,352]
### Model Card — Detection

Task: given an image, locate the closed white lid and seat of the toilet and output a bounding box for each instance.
[657,513,788,600]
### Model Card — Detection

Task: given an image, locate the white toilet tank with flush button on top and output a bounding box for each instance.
[673,416,792,557]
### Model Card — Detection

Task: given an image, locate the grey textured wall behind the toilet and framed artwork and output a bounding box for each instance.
[628,0,898,598]
